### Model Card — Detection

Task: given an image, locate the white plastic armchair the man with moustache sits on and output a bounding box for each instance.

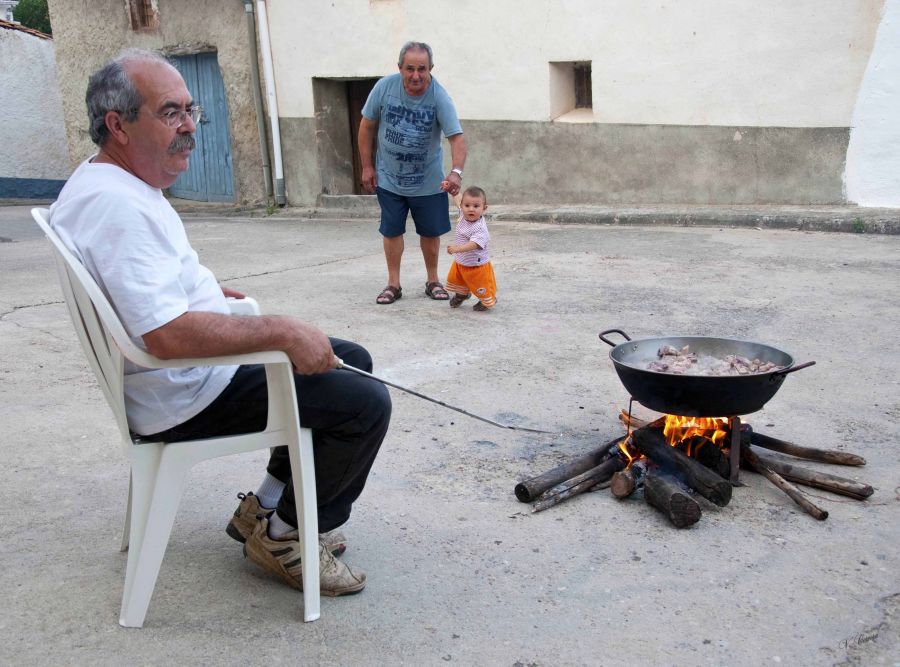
[31,208,319,628]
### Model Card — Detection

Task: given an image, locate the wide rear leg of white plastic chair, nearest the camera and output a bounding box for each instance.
[119,445,190,628]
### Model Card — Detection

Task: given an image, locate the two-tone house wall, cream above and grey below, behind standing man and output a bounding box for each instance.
[260,0,883,204]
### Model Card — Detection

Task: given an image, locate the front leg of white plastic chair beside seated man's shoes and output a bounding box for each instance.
[291,428,321,622]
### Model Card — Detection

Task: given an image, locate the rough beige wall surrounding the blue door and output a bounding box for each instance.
[49,0,265,203]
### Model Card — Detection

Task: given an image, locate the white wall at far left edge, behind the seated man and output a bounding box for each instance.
[0,28,70,179]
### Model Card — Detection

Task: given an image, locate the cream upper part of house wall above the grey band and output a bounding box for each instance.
[267,0,884,127]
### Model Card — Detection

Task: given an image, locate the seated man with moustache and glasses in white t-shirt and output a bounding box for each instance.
[50,50,391,596]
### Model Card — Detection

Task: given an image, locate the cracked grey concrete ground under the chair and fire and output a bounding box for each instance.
[0,207,900,666]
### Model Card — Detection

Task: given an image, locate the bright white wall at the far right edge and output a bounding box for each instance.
[845,0,900,207]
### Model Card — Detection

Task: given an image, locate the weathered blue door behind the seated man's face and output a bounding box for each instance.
[169,53,234,202]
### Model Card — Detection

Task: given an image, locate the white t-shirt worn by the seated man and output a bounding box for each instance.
[50,158,237,435]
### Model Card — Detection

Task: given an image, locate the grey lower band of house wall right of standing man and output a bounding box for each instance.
[465,121,848,204]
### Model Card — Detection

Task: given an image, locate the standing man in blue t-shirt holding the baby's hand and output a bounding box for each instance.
[359,42,466,304]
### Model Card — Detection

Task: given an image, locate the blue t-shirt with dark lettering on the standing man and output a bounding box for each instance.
[362,72,462,197]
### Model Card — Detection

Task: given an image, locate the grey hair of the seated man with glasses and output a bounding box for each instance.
[84,49,171,146]
